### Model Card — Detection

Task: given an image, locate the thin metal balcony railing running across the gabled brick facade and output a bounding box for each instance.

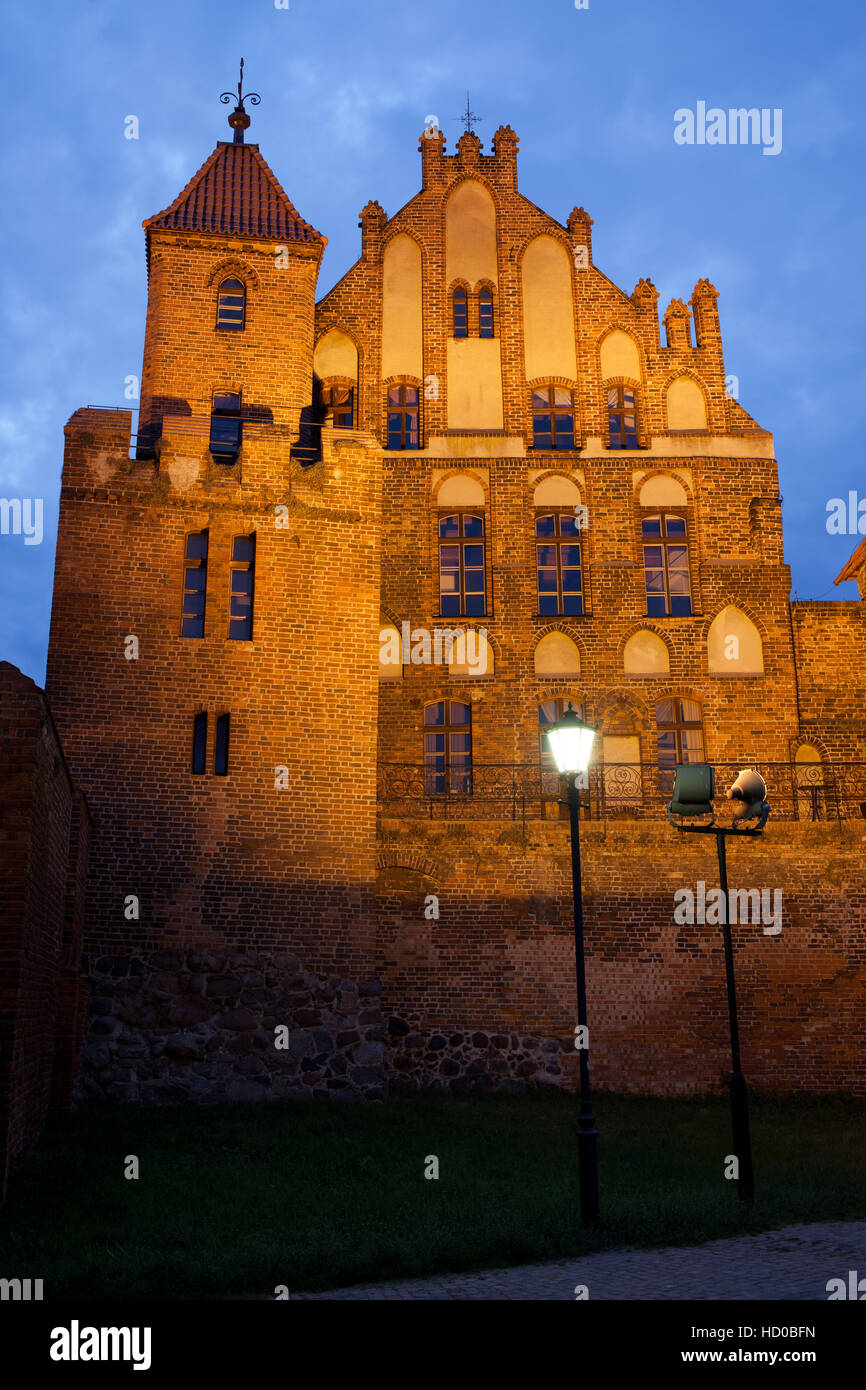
[378,758,866,821]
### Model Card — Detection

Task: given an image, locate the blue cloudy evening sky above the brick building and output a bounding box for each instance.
[0,0,866,682]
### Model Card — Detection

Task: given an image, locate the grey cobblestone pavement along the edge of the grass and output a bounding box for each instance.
[292,1222,866,1301]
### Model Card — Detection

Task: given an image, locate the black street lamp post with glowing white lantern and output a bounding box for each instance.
[548,702,599,1226]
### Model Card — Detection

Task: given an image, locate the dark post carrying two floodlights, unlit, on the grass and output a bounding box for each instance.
[667,763,770,1205]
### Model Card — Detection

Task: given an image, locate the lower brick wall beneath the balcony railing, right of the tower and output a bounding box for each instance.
[378,819,866,1095]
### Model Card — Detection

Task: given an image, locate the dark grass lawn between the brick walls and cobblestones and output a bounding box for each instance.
[0,1094,866,1298]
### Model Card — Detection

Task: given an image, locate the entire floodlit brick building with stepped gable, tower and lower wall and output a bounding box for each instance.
[47,92,866,1101]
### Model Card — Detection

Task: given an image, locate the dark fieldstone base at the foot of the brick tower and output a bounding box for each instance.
[78,951,386,1105]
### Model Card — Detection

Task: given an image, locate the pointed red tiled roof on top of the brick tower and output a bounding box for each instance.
[142,140,328,246]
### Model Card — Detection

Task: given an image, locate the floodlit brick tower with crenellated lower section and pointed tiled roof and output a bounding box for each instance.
[47,83,381,1098]
